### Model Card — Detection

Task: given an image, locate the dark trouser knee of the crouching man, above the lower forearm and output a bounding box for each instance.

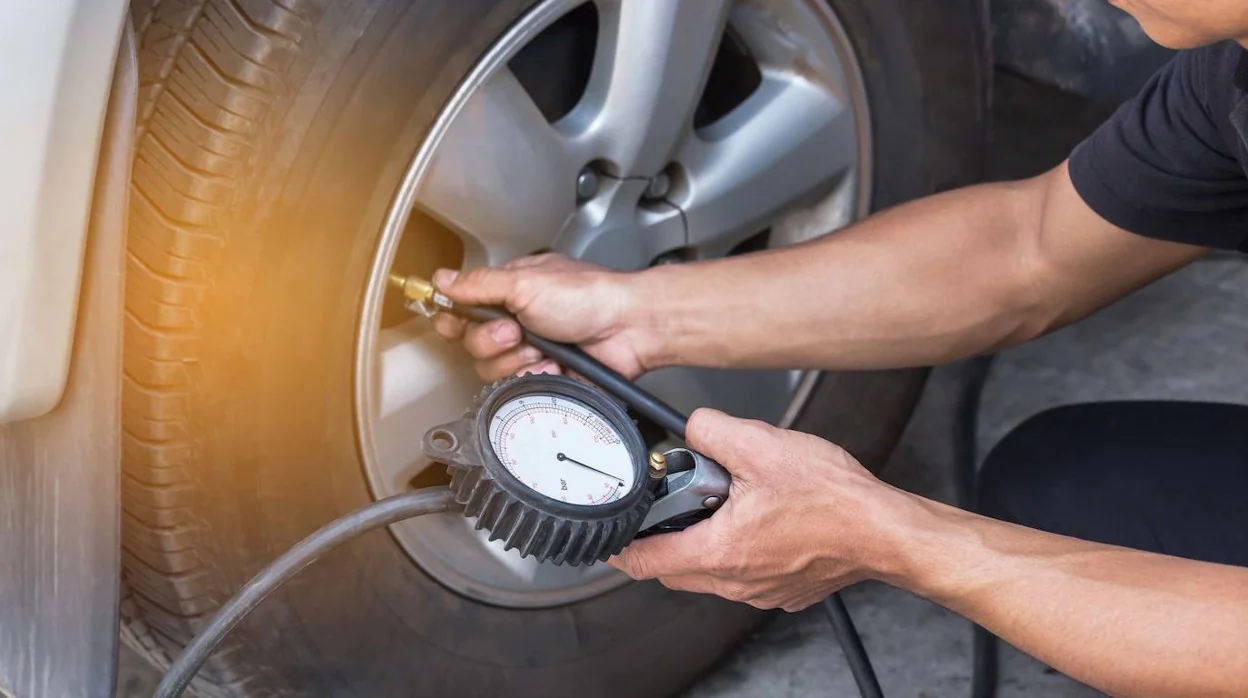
[978,402,1248,567]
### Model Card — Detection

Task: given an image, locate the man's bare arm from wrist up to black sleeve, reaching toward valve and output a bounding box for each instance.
[636,165,1206,368]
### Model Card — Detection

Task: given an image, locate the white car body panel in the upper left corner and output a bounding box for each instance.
[0,0,127,423]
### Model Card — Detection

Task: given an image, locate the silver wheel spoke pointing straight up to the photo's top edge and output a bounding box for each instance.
[559,0,730,177]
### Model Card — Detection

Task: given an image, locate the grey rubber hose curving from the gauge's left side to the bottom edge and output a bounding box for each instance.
[155,487,459,698]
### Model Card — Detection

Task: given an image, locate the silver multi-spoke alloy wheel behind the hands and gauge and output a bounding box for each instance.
[356,0,871,608]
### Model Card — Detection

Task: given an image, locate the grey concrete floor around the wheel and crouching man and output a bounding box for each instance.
[119,76,1248,698]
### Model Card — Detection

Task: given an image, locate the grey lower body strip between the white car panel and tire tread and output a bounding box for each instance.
[0,17,139,698]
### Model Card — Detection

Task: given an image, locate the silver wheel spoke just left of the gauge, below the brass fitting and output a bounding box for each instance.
[374,320,480,484]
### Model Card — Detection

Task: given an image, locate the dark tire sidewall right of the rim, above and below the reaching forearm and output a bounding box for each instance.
[794,0,992,472]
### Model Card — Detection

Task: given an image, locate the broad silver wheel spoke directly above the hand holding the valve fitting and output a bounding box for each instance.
[418,69,588,266]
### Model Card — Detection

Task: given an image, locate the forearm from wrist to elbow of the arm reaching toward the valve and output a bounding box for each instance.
[624,177,1040,370]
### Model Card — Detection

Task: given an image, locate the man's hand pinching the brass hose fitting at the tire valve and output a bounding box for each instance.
[433,255,649,381]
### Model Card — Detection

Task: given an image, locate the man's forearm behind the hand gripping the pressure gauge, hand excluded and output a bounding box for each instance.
[890,501,1248,697]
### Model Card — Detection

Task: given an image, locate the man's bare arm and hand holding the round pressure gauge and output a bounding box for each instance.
[613,410,1248,698]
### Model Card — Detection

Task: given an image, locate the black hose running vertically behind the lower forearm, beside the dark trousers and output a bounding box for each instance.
[953,355,998,698]
